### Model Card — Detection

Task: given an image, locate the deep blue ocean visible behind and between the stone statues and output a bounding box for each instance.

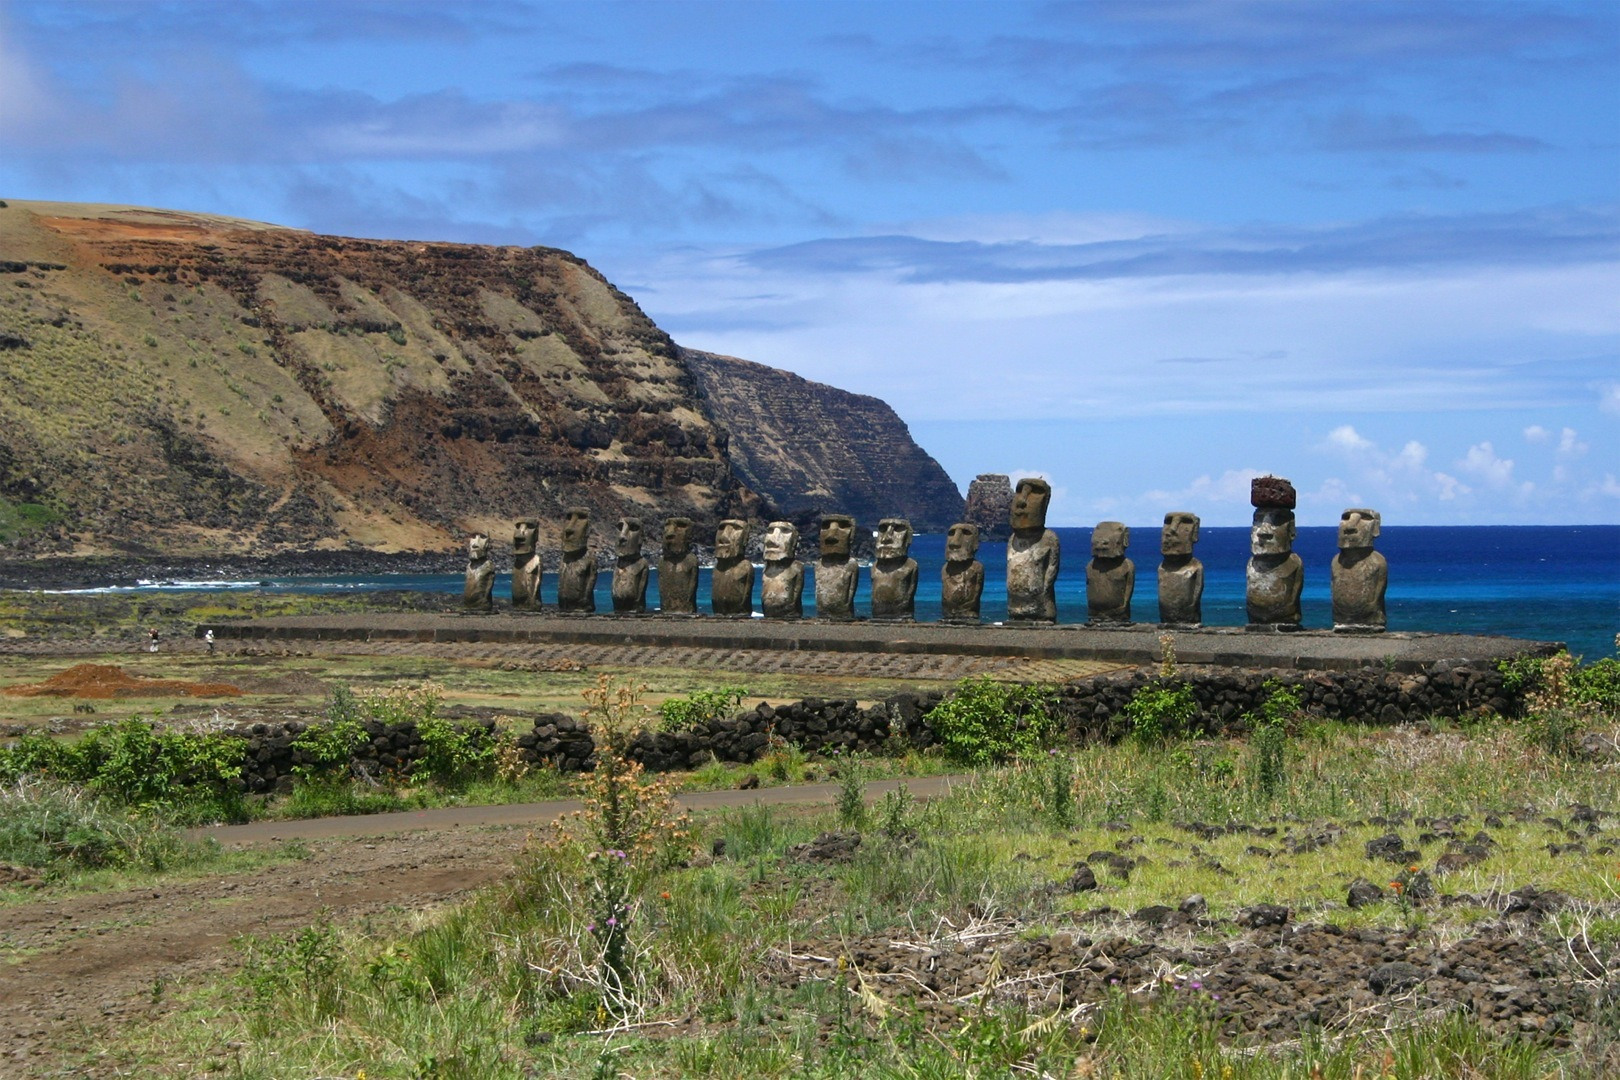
[78,525,1620,661]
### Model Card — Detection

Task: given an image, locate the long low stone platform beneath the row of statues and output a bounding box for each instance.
[198,612,1560,672]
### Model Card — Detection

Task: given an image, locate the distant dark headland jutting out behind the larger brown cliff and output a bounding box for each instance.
[682,348,962,531]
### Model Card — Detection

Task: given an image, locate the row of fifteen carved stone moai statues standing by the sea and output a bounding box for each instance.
[463,476,1388,631]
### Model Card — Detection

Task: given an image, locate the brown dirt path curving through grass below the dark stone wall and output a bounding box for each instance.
[0,777,966,1077]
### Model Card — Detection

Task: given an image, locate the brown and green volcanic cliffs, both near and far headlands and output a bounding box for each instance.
[0,201,961,554]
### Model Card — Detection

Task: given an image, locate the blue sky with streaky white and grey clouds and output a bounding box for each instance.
[0,0,1620,525]
